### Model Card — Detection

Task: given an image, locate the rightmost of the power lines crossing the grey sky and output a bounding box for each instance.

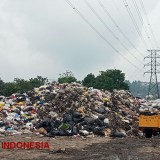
[140,0,159,48]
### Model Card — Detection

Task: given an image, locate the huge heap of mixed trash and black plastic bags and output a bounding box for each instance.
[0,83,140,137]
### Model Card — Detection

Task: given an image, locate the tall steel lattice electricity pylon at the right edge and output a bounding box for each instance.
[144,50,160,98]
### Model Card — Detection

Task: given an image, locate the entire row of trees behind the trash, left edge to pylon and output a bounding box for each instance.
[0,69,148,98]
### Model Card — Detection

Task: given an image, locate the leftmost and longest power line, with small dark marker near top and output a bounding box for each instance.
[66,0,139,69]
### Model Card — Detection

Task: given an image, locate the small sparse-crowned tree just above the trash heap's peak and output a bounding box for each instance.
[58,71,77,83]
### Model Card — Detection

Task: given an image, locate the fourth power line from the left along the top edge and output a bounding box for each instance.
[123,0,148,49]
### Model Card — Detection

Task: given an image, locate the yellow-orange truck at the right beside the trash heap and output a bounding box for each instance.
[139,112,160,138]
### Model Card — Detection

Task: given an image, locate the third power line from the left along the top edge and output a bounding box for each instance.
[97,0,143,56]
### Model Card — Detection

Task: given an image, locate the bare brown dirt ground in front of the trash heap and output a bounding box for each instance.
[0,135,160,160]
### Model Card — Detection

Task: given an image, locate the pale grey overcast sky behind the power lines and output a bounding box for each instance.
[0,0,160,81]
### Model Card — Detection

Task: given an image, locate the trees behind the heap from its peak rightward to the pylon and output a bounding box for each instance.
[58,69,152,98]
